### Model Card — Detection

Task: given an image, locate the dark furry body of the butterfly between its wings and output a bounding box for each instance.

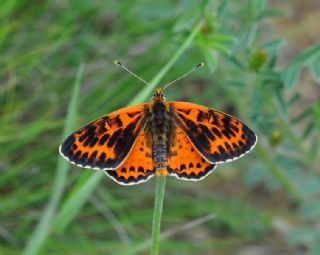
[145,97,175,175]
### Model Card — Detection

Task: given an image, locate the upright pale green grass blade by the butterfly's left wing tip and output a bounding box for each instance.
[23,64,84,255]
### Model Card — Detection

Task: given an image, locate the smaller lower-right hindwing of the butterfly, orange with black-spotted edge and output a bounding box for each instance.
[168,127,216,181]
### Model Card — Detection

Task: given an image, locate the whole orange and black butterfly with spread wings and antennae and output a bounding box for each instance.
[59,62,257,185]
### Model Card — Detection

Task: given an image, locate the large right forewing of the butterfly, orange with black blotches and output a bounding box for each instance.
[170,102,257,164]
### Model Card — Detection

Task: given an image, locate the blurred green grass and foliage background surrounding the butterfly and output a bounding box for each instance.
[0,0,320,255]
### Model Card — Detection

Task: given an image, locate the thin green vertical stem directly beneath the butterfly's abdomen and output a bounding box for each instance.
[151,176,166,255]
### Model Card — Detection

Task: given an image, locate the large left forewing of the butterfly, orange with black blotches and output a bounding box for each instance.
[59,104,146,170]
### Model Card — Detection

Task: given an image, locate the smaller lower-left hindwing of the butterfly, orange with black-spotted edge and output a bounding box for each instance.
[106,130,154,185]
